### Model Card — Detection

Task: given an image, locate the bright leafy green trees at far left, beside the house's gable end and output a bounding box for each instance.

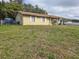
[0,2,23,19]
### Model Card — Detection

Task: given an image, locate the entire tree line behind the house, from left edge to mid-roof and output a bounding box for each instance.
[0,1,47,19]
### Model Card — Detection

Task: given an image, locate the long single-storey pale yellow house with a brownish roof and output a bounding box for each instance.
[16,11,60,25]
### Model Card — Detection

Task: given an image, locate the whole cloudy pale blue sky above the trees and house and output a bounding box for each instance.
[0,0,79,19]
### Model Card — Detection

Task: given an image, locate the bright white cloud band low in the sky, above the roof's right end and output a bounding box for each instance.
[49,7,79,19]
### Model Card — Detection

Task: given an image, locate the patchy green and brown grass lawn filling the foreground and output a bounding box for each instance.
[0,25,79,59]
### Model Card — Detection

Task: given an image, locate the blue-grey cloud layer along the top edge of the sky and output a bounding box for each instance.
[26,0,79,7]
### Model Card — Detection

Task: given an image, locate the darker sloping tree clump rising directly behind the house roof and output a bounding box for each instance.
[24,4,48,14]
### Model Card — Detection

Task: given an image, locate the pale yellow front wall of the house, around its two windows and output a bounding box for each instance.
[23,16,52,25]
